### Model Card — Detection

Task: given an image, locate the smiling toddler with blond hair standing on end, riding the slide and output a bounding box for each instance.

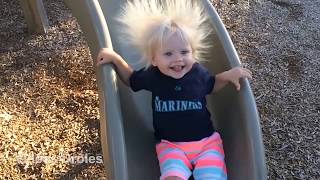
[97,0,251,180]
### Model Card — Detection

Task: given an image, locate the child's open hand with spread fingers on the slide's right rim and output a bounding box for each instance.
[225,67,252,91]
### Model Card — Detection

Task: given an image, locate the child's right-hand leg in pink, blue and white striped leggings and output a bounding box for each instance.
[193,133,227,180]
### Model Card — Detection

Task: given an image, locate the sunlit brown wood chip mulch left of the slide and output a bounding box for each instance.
[0,0,106,179]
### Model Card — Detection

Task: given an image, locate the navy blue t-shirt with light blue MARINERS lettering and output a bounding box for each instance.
[130,63,215,142]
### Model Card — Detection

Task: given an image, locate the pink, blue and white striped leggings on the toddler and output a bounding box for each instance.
[156,132,227,180]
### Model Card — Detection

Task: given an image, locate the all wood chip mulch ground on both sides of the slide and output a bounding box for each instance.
[0,0,320,179]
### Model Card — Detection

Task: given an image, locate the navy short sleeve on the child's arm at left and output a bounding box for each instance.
[129,68,153,92]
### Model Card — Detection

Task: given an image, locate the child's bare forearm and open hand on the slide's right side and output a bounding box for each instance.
[213,67,252,92]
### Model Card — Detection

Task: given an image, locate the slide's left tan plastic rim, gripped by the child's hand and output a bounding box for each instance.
[64,0,128,180]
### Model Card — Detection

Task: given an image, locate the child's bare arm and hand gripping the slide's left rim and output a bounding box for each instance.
[97,48,133,86]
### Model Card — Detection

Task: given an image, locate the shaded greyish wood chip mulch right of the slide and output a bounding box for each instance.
[214,0,320,180]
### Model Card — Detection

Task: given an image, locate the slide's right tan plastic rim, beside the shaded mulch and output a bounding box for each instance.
[201,0,267,180]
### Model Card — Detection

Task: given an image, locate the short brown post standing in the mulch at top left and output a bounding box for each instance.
[20,0,49,33]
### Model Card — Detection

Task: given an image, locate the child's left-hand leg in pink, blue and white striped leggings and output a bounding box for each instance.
[156,141,191,180]
